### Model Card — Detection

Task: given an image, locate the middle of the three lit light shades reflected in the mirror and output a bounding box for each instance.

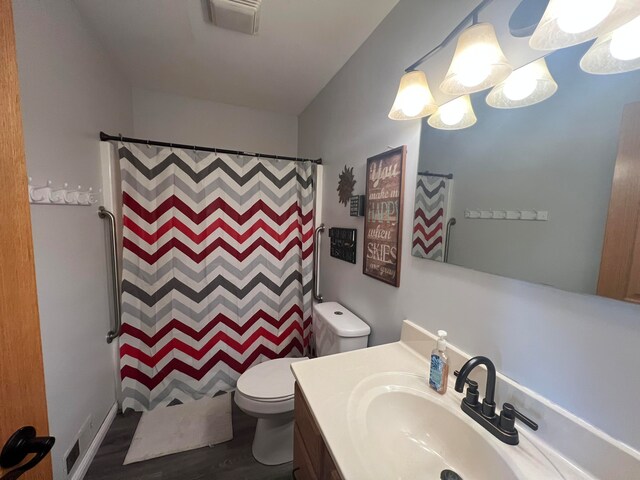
[487,58,558,108]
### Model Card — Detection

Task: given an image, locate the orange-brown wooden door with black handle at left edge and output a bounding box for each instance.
[0,0,52,480]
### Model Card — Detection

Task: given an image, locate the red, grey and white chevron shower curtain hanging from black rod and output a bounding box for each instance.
[119,144,315,410]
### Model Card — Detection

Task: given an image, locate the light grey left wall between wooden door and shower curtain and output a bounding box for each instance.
[13,0,132,480]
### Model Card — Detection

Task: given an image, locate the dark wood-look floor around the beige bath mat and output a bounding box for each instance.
[85,402,292,480]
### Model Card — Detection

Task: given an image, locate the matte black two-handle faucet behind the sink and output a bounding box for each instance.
[454,357,538,445]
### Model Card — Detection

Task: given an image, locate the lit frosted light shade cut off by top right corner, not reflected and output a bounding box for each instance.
[529,0,640,50]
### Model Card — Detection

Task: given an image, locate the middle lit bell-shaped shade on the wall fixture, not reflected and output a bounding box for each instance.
[440,23,513,95]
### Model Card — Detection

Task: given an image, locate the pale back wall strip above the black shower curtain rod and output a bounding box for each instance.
[132,88,298,156]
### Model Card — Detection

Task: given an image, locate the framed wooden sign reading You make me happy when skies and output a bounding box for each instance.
[362,146,407,287]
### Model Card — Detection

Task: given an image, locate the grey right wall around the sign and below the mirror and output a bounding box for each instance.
[299,0,640,449]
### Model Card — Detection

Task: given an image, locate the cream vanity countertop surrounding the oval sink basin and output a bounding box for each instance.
[291,334,593,480]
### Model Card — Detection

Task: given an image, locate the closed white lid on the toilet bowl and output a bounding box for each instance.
[237,357,308,401]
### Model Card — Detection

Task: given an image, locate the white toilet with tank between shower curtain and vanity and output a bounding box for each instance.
[234,302,371,465]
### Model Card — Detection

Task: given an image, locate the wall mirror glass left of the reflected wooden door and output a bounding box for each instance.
[412,44,640,300]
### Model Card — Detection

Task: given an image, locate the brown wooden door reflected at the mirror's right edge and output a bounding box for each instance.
[598,103,640,303]
